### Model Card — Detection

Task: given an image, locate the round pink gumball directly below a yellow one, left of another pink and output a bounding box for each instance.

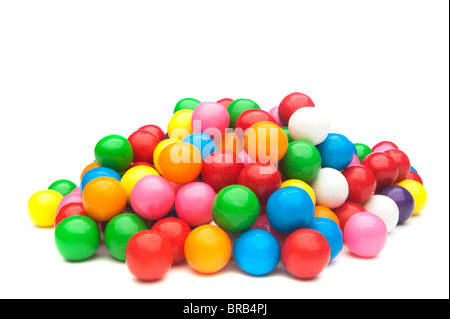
[130,175,175,220]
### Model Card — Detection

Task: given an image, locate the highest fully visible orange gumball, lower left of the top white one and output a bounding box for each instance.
[244,121,288,163]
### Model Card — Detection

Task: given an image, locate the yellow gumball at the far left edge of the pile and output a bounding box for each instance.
[28,189,63,227]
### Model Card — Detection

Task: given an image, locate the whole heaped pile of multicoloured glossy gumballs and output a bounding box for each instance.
[28,92,427,280]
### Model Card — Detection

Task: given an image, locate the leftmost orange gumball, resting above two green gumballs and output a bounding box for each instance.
[82,177,127,222]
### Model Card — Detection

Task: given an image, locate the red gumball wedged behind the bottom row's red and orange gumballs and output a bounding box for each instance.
[152,217,191,264]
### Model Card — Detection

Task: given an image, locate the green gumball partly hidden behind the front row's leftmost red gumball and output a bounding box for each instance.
[105,214,148,260]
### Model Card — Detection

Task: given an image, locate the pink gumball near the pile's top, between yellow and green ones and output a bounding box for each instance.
[192,102,230,135]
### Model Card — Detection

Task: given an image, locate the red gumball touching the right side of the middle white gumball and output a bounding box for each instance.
[342,165,377,203]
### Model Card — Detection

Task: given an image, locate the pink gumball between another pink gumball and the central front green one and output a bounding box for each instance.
[175,182,216,227]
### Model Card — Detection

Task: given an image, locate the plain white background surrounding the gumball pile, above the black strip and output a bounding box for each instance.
[0,0,449,298]
